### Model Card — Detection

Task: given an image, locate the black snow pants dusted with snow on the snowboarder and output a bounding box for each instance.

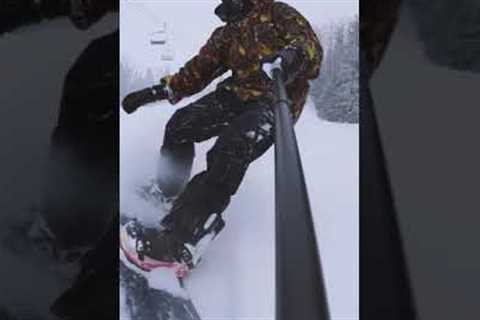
[158,88,275,242]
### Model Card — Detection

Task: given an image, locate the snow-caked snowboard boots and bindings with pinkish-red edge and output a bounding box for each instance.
[120,214,225,279]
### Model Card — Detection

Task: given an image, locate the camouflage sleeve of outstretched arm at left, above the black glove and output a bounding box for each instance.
[162,27,227,104]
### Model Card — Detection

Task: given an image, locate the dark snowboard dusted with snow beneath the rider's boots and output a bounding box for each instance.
[120,185,201,320]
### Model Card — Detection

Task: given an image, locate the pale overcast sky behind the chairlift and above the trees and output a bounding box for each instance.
[120,0,358,68]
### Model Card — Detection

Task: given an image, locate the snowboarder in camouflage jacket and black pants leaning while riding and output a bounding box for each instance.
[120,0,323,278]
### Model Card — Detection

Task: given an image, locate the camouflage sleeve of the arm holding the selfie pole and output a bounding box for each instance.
[273,2,323,79]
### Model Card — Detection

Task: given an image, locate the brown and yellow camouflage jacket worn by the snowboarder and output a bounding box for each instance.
[162,0,323,117]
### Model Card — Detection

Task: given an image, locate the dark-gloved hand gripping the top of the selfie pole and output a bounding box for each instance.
[262,47,304,84]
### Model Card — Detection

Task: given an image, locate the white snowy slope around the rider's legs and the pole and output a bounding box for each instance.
[120,99,358,320]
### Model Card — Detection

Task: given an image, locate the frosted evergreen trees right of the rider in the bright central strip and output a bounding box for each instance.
[311,17,359,123]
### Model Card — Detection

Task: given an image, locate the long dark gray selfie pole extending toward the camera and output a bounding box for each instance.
[273,68,330,320]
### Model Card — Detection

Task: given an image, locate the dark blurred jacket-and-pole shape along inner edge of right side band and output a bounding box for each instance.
[360,0,416,320]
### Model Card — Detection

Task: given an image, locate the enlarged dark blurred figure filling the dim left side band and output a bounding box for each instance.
[0,0,119,319]
